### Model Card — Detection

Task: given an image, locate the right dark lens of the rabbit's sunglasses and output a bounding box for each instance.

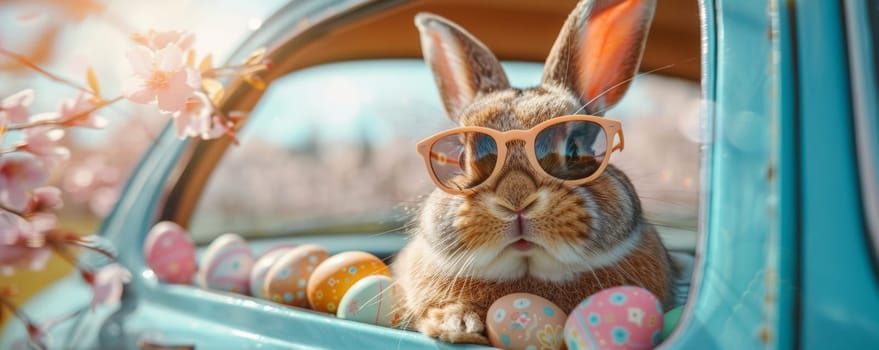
[534,121,607,180]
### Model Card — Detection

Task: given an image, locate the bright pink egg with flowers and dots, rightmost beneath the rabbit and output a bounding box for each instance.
[565,286,663,349]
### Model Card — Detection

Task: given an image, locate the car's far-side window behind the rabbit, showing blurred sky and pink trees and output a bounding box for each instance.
[190,60,699,246]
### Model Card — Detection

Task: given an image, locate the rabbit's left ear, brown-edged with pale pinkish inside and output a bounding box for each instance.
[415,13,510,121]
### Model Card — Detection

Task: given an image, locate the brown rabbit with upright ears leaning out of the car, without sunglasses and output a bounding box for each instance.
[392,0,673,344]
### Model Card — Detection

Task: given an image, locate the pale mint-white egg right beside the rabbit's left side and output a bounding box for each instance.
[336,275,400,327]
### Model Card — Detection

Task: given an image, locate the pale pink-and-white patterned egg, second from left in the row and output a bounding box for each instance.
[195,233,253,294]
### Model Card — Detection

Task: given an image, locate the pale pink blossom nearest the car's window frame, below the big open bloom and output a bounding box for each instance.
[172,92,226,140]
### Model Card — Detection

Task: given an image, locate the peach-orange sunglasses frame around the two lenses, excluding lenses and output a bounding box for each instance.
[417,115,625,195]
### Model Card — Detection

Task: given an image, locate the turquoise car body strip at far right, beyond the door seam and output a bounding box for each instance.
[796,1,879,349]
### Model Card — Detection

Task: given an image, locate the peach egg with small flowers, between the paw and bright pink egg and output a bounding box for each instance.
[485,293,566,349]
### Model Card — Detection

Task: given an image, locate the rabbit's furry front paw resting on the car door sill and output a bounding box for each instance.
[418,304,488,344]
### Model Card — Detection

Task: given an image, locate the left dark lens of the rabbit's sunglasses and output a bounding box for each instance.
[430,132,497,190]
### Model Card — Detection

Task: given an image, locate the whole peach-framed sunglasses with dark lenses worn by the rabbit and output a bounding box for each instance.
[418,115,624,195]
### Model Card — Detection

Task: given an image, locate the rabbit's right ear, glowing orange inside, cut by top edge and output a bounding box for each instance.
[543,0,655,114]
